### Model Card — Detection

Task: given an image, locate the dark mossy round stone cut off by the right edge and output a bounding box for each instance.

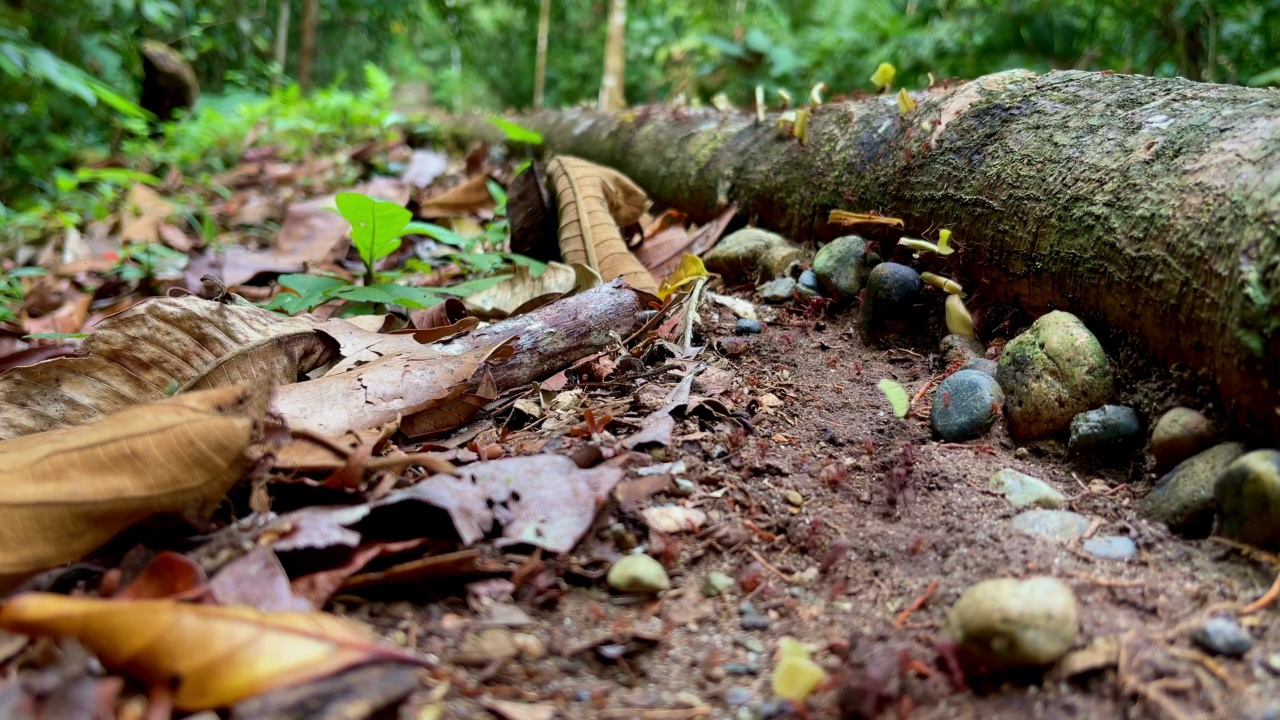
[1213,450,1280,547]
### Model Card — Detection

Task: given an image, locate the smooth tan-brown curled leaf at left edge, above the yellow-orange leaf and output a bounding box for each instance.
[0,387,268,592]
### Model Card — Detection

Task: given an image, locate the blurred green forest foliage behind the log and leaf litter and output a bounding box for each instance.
[0,0,1280,225]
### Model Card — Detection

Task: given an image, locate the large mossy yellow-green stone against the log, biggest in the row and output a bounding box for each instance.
[996,310,1114,441]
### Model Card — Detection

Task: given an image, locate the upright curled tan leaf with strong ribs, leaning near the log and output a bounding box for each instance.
[547,155,658,292]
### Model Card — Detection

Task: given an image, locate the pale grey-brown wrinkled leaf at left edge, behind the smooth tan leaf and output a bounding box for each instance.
[0,296,337,439]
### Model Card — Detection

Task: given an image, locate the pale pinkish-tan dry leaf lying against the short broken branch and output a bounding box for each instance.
[273,336,507,436]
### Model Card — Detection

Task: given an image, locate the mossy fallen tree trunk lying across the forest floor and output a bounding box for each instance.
[455,70,1280,438]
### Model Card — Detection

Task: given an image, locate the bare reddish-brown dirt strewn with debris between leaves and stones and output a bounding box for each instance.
[353,298,1280,720]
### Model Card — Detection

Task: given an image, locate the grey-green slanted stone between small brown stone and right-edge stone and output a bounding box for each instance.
[1138,442,1244,538]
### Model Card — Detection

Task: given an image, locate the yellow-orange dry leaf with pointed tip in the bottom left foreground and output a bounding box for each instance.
[0,593,422,711]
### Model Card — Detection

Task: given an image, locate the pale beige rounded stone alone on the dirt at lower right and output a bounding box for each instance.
[942,577,1078,670]
